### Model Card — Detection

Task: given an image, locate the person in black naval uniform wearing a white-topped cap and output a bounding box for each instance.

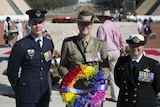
[114,34,160,107]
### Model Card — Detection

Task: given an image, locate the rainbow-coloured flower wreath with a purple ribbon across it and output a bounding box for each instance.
[60,66,107,107]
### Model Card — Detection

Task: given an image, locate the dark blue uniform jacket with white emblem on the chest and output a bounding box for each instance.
[7,34,54,103]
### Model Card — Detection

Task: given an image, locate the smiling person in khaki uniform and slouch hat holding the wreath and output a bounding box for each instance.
[58,10,109,106]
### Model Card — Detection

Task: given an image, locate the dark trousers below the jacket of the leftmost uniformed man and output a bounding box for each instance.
[16,90,50,107]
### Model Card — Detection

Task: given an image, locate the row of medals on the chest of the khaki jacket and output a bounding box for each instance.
[85,52,101,62]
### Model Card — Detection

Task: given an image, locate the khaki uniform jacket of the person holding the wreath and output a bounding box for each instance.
[59,36,108,77]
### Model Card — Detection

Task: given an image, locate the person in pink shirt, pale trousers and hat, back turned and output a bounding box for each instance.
[97,10,125,102]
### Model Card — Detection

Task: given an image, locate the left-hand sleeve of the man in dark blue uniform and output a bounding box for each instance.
[7,43,24,90]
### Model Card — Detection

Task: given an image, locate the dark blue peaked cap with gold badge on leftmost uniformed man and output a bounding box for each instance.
[26,8,47,22]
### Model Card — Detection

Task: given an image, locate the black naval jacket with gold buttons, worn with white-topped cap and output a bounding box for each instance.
[114,56,160,107]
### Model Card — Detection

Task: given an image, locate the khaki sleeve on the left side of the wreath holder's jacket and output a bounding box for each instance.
[58,39,69,78]
